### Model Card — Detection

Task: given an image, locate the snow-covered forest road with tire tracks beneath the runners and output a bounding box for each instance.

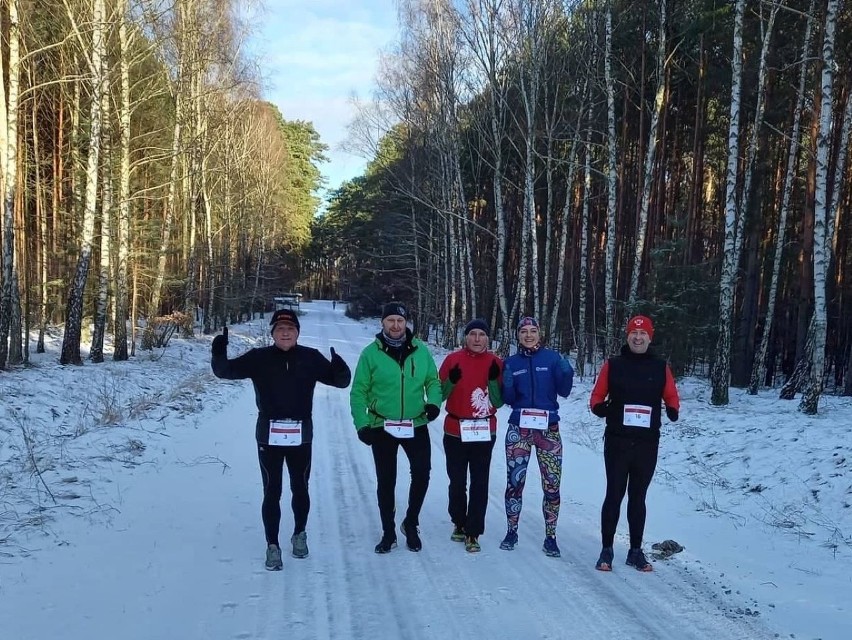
[0,303,800,640]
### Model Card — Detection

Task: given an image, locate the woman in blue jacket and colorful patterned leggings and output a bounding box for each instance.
[500,317,574,558]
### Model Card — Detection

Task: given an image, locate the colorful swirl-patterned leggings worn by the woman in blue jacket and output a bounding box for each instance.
[506,424,562,537]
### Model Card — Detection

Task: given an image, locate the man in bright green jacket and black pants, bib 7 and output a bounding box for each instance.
[350,302,442,553]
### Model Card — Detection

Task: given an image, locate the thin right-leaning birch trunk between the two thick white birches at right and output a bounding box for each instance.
[748,0,814,395]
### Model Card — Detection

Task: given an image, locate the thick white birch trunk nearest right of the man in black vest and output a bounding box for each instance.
[710,0,745,405]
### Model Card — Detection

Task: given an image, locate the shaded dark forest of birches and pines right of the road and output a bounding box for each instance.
[303,0,852,412]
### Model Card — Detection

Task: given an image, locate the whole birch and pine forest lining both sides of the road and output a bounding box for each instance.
[0,0,852,413]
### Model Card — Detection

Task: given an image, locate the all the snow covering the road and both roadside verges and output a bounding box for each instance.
[0,301,852,640]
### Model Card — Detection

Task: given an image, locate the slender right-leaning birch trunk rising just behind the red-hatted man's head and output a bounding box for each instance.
[627,0,667,311]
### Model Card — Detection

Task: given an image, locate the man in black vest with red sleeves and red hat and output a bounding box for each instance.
[589,316,680,571]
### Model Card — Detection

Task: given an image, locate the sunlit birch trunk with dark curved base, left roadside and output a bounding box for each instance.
[59,0,107,364]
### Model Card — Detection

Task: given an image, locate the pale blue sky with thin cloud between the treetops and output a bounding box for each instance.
[251,0,396,200]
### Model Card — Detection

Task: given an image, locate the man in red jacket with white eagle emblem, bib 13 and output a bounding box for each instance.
[438,318,503,553]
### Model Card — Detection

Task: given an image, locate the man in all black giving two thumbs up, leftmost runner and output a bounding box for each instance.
[211,309,352,571]
